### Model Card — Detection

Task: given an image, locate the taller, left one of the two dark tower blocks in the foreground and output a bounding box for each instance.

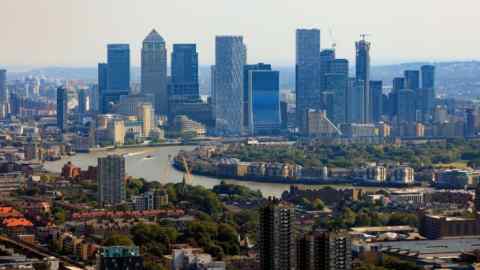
[257,199,296,270]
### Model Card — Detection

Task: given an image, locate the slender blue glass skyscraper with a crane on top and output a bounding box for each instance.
[355,39,372,123]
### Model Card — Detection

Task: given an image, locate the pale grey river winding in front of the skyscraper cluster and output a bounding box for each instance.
[44,146,352,197]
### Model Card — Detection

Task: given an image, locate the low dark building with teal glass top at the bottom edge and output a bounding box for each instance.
[96,246,144,270]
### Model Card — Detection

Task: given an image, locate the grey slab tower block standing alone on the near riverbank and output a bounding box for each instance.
[97,155,126,206]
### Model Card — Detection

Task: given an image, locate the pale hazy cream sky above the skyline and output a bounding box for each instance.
[0,0,480,67]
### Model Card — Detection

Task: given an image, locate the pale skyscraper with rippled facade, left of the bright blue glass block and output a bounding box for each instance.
[214,36,247,135]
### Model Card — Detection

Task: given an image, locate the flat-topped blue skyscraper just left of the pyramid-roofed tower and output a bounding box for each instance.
[107,44,130,92]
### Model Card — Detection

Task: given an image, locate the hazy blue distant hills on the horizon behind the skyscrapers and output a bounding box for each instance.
[9,61,480,99]
